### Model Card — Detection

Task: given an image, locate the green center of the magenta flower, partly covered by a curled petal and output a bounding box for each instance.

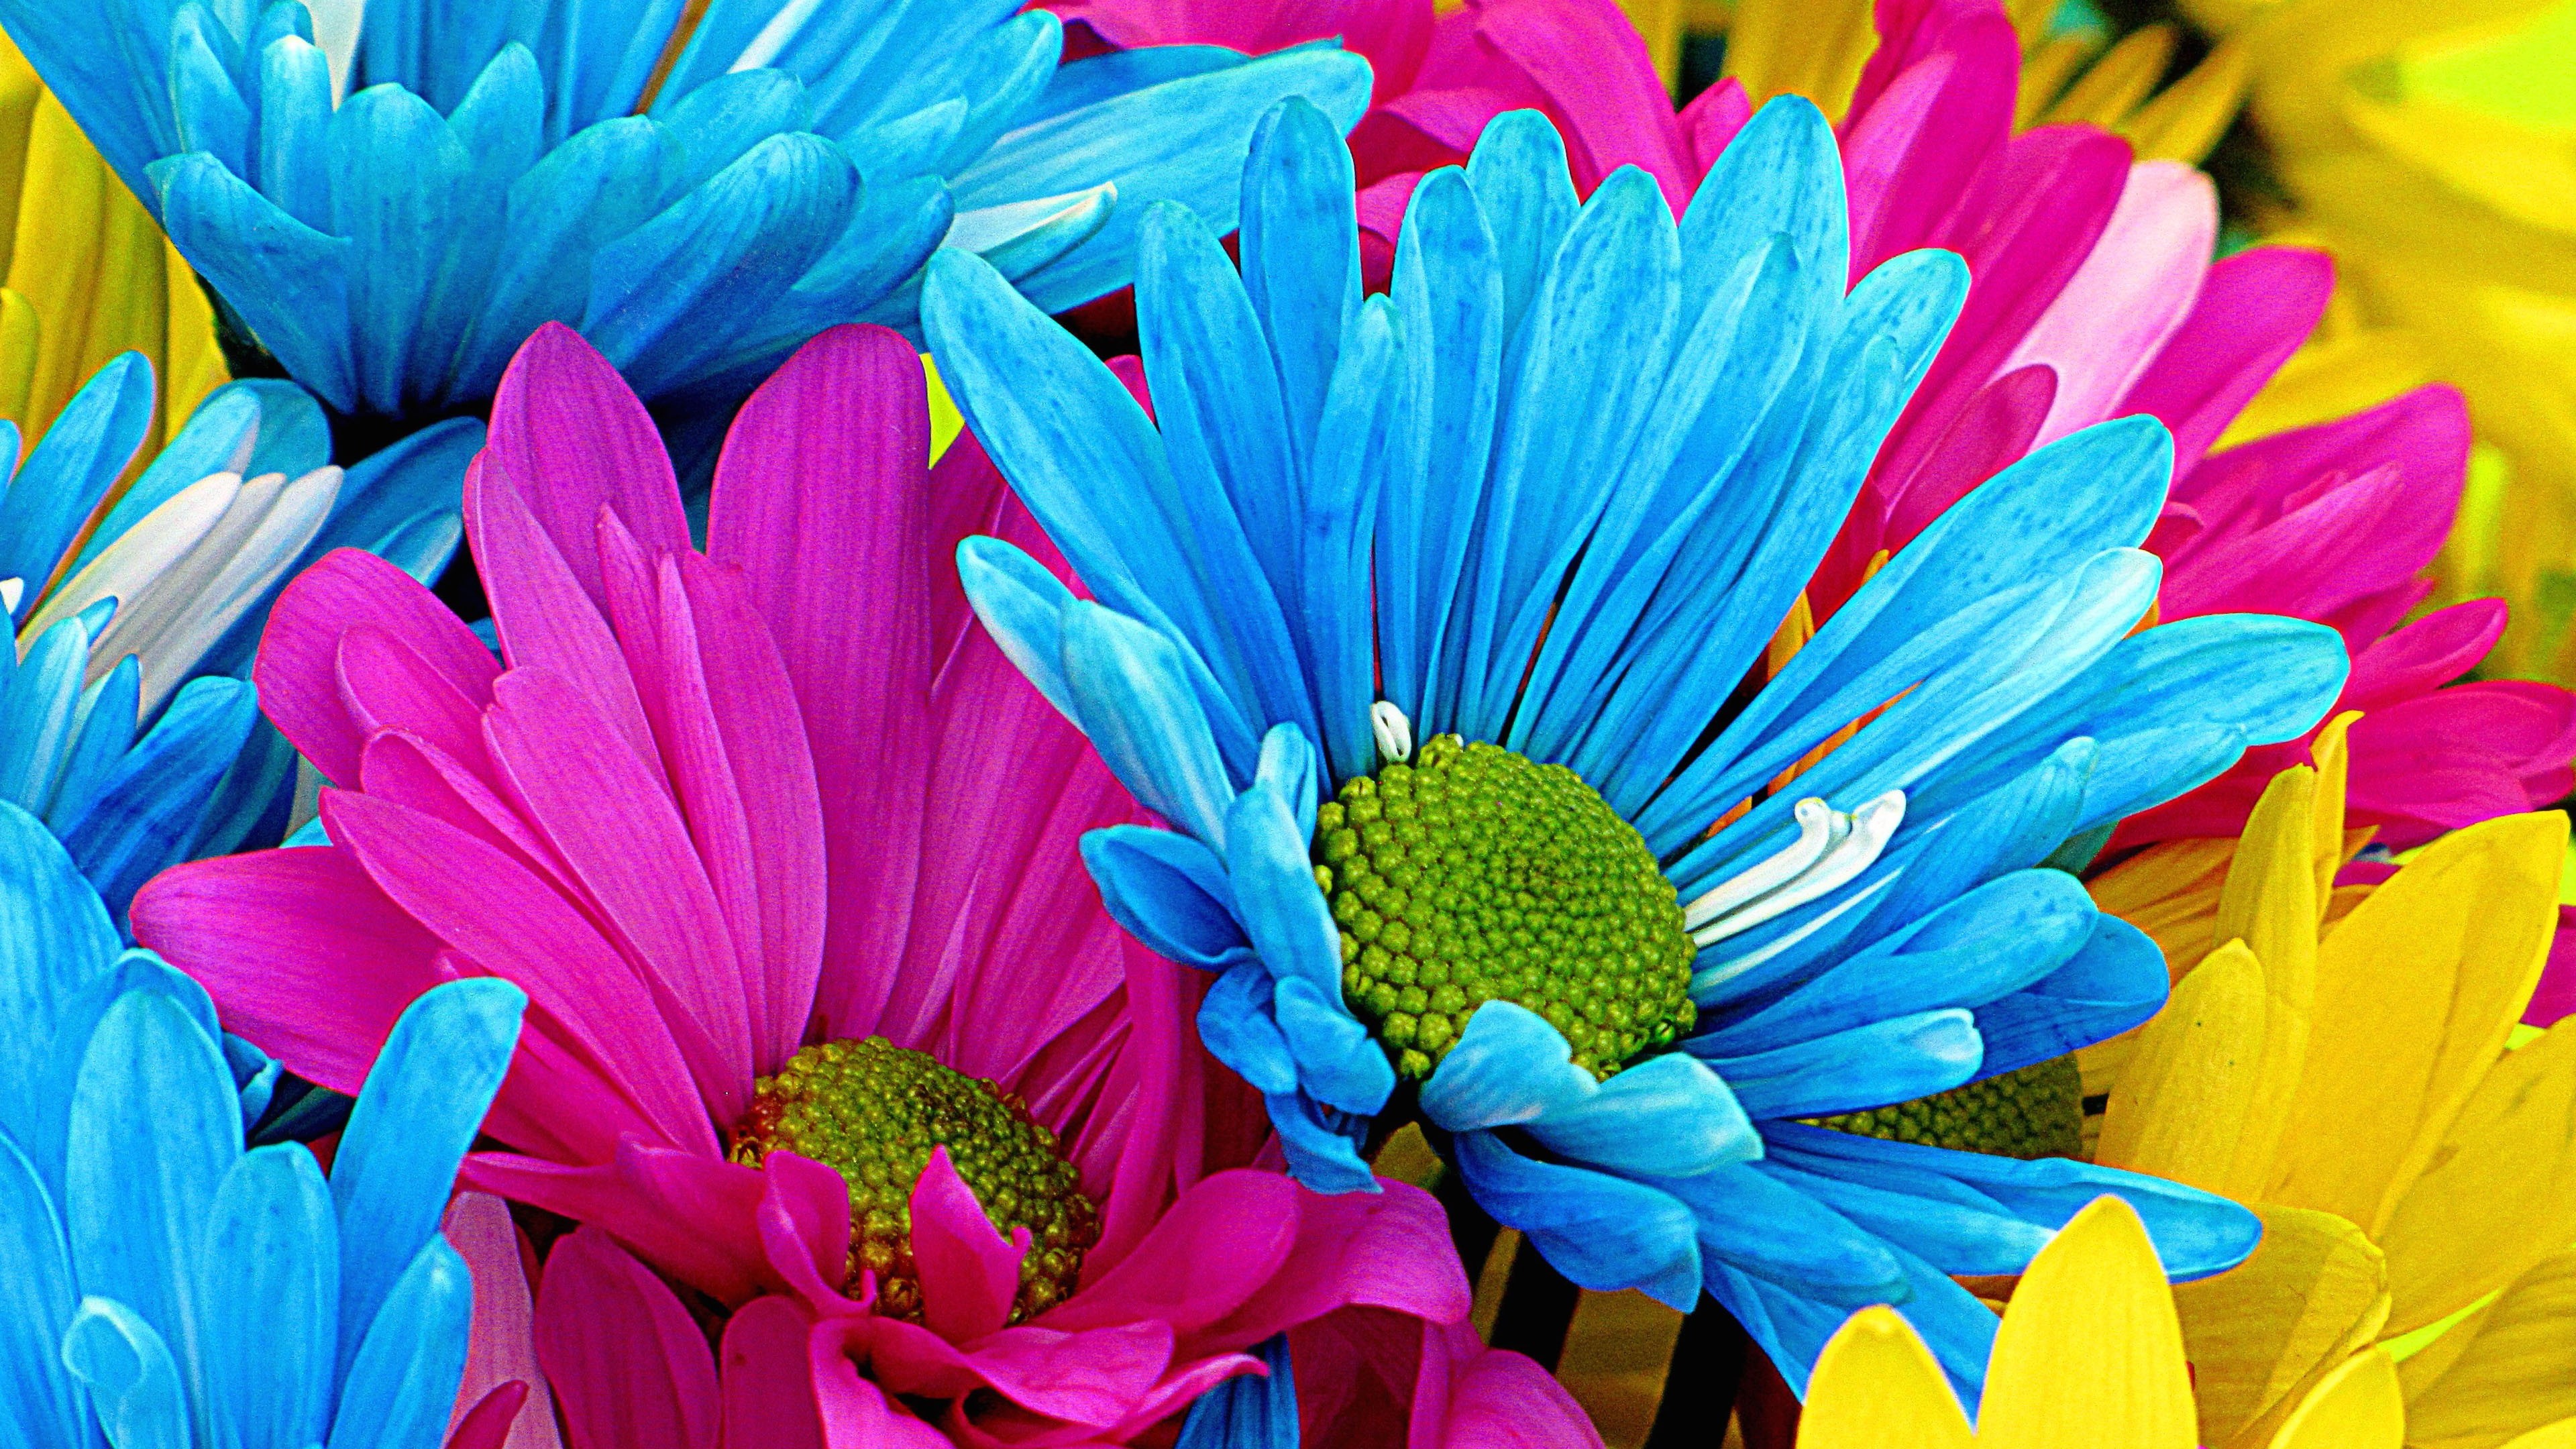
[732,1036,1100,1323]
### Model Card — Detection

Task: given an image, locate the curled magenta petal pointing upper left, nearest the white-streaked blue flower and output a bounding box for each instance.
[250,549,500,784]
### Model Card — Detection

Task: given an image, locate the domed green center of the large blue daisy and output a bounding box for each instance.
[1313,735,1698,1080]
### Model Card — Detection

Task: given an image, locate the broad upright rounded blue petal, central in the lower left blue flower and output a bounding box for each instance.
[62,993,242,1377]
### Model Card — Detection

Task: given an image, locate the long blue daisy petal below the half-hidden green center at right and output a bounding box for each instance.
[1762,1122,2262,1281]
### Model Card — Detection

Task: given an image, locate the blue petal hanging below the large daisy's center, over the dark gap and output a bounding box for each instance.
[1450,1132,1700,1312]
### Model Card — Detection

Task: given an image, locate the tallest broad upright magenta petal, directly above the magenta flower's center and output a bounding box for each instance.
[708,327,956,1034]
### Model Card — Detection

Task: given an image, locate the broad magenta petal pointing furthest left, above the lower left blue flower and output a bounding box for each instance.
[134,848,441,1093]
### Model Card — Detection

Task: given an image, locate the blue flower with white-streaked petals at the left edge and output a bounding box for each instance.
[0,354,482,920]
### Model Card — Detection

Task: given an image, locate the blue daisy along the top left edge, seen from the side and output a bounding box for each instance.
[0,0,1371,430]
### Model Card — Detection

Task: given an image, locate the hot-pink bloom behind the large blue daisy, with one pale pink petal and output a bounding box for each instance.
[1056,0,2576,848]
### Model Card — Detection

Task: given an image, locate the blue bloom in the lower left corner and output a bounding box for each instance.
[0,804,525,1449]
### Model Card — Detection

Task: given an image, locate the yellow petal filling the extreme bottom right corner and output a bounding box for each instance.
[2398,1248,2576,1449]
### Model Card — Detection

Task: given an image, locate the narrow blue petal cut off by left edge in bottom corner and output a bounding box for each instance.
[0,1132,95,1446]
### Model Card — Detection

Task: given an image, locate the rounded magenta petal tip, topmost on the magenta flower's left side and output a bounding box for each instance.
[476,322,688,606]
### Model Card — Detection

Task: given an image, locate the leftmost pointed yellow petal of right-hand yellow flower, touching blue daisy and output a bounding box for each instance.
[2094,941,2267,1191]
